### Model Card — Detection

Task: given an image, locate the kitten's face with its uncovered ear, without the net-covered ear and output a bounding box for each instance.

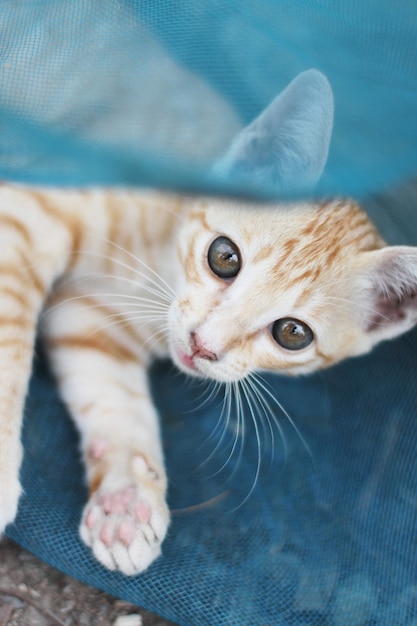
[169,200,417,381]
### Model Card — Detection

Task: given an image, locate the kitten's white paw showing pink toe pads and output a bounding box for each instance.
[80,484,169,576]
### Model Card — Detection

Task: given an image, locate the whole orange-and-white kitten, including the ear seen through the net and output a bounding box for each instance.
[0,71,417,575]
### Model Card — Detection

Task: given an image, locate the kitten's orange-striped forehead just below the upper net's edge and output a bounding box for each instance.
[182,194,381,276]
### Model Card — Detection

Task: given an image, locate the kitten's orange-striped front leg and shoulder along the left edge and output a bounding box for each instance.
[0,202,75,535]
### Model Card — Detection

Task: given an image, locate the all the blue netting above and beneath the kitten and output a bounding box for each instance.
[0,0,417,626]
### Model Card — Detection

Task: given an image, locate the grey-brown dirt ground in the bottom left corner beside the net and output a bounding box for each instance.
[0,538,175,626]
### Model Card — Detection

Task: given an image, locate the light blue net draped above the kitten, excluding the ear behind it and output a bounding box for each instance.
[0,0,417,195]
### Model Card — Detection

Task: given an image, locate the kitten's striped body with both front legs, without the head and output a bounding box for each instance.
[0,186,185,573]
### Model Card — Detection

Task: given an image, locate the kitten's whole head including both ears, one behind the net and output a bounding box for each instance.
[169,70,417,381]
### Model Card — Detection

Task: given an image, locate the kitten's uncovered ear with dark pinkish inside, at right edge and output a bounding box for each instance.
[364,246,417,344]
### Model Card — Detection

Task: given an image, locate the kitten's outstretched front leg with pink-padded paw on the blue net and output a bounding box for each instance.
[46,300,169,575]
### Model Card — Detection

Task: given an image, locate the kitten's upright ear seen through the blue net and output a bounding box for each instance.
[214,69,333,189]
